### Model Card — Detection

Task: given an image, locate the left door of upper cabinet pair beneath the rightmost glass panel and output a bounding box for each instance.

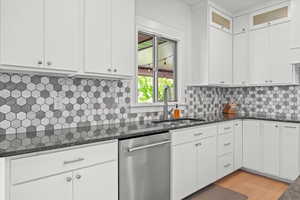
[249,28,272,84]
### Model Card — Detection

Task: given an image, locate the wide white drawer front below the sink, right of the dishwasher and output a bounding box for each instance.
[171,126,218,145]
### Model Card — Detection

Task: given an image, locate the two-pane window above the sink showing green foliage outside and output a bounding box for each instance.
[137,32,177,103]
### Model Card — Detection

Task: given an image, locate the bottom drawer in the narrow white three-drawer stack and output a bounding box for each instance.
[218,153,233,178]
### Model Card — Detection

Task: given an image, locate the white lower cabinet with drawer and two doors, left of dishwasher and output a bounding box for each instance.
[7,142,118,200]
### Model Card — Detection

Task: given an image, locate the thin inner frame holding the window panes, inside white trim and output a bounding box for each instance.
[136,31,178,104]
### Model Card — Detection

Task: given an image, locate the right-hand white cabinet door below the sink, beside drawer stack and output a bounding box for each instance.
[195,137,217,189]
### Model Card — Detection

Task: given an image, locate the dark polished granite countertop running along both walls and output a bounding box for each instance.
[0,114,300,157]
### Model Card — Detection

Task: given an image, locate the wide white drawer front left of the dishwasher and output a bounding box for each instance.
[11,142,118,184]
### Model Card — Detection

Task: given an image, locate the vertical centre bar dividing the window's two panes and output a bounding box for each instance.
[153,36,158,103]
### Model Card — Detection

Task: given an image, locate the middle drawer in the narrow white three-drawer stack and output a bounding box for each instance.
[218,132,233,156]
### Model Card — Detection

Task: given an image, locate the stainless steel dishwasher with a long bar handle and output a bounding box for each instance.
[119,133,171,200]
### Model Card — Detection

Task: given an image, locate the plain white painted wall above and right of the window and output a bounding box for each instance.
[136,0,191,108]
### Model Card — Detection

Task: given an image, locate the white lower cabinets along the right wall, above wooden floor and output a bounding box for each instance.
[243,120,300,181]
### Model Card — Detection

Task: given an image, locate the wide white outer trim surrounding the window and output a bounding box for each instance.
[130,16,189,113]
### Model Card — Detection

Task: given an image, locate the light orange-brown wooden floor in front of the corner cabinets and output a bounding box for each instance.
[216,171,288,200]
